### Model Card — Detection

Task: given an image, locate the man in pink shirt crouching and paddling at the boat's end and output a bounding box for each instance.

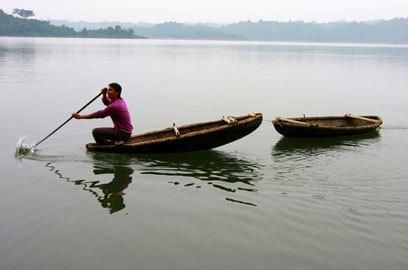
[72,83,133,144]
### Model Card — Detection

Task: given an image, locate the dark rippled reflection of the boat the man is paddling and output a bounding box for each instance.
[88,150,262,205]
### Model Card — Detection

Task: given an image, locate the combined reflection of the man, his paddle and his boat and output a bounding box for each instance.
[41,150,263,210]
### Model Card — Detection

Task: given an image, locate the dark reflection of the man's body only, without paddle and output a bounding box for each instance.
[94,166,133,214]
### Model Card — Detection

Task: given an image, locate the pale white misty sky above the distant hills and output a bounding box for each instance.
[0,0,408,23]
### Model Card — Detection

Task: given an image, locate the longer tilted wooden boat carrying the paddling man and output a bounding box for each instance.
[86,113,262,154]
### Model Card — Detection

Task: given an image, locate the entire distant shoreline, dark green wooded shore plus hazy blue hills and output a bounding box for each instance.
[0,9,408,45]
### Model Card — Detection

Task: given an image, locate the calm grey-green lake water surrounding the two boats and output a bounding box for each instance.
[0,37,408,270]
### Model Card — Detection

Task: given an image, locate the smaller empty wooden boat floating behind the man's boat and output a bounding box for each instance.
[272,114,383,138]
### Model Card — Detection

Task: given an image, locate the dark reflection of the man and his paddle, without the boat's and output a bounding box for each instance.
[45,162,133,214]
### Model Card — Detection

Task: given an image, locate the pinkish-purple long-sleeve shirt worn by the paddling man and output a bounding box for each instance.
[92,98,133,133]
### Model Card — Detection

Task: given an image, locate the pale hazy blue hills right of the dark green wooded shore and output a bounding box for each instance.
[132,18,408,43]
